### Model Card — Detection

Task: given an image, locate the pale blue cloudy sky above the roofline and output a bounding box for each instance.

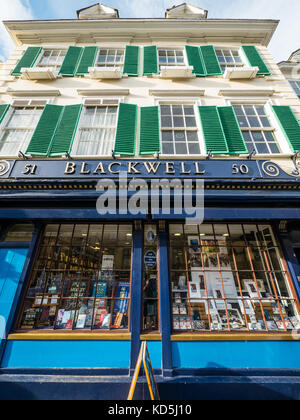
[0,0,300,62]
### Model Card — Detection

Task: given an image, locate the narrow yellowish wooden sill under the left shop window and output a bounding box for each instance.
[7,331,131,341]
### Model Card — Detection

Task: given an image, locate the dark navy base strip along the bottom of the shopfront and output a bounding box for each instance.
[0,370,300,401]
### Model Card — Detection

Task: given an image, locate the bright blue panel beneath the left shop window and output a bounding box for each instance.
[1,341,130,368]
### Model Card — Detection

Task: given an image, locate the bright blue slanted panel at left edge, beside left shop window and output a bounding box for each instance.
[0,248,28,348]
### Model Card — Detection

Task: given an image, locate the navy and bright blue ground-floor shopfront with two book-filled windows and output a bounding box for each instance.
[0,160,300,399]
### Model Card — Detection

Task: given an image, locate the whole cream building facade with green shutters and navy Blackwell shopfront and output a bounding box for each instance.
[0,4,300,399]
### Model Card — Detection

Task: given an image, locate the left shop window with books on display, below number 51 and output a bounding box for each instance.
[18,224,132,331]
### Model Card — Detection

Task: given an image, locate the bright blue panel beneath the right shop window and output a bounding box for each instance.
[172,341,300,369]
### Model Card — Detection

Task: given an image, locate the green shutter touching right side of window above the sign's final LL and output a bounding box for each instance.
[198,106,229,154]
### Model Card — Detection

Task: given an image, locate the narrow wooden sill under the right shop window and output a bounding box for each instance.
[171,332,295,342]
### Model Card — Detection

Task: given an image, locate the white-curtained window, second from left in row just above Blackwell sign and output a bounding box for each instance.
[73,100,119,156]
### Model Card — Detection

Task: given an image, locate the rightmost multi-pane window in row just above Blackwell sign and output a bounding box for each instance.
[234,105,280,154]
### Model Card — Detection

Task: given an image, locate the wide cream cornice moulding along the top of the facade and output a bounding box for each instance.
[4,19,279,46]
